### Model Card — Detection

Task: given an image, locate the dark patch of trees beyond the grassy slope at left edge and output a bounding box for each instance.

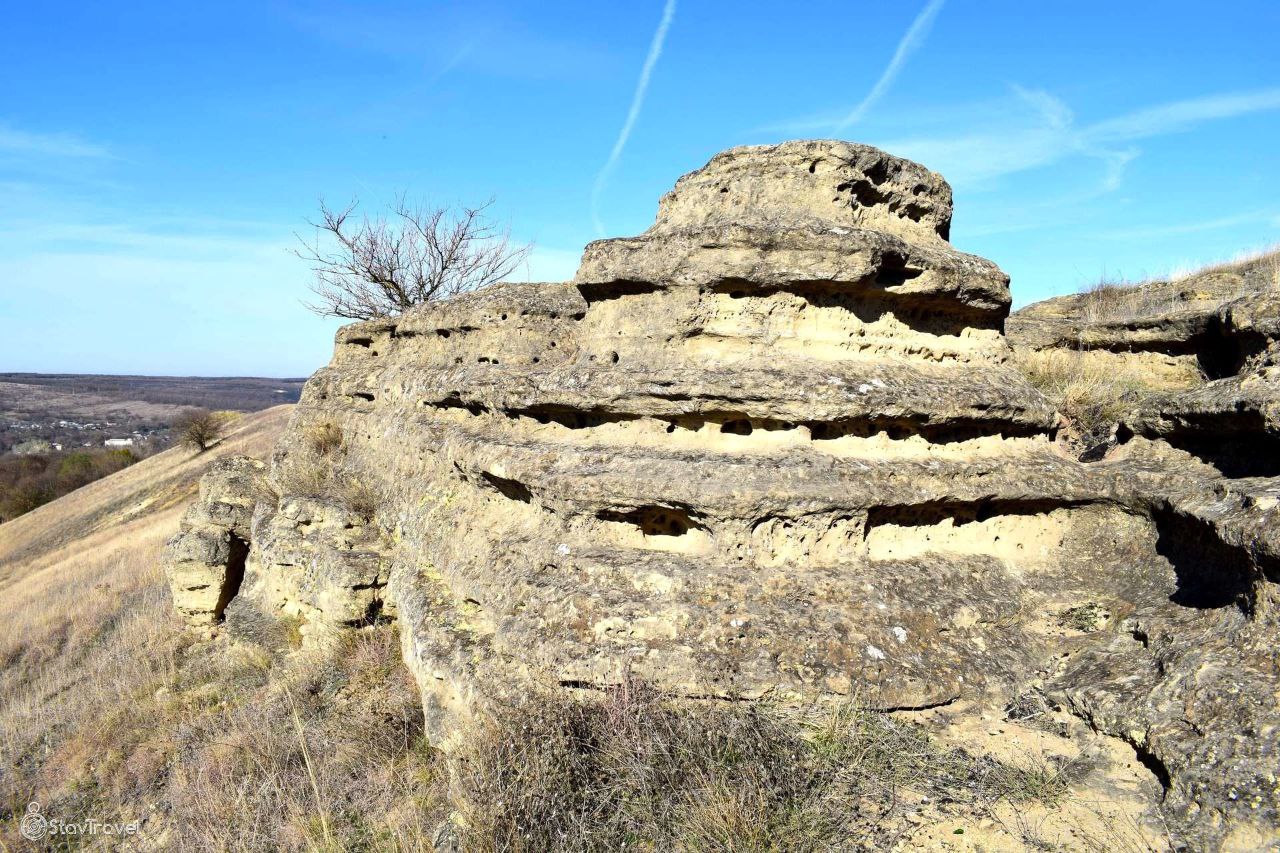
[0,447,138,521]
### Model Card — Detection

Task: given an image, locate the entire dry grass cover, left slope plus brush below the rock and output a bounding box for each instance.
[0,404,1136,850]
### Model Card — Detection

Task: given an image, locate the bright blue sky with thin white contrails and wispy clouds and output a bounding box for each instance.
[0,0,1280,375]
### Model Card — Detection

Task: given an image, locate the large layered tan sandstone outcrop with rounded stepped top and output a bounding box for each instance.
[170,141,1280,847]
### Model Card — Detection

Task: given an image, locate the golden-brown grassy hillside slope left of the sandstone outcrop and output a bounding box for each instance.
[0,406,440,850]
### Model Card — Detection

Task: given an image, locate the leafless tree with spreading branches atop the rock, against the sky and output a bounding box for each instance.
[294,197,530,320]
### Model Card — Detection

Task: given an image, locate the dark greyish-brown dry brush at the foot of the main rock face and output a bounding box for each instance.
[449,684,1066,852]
